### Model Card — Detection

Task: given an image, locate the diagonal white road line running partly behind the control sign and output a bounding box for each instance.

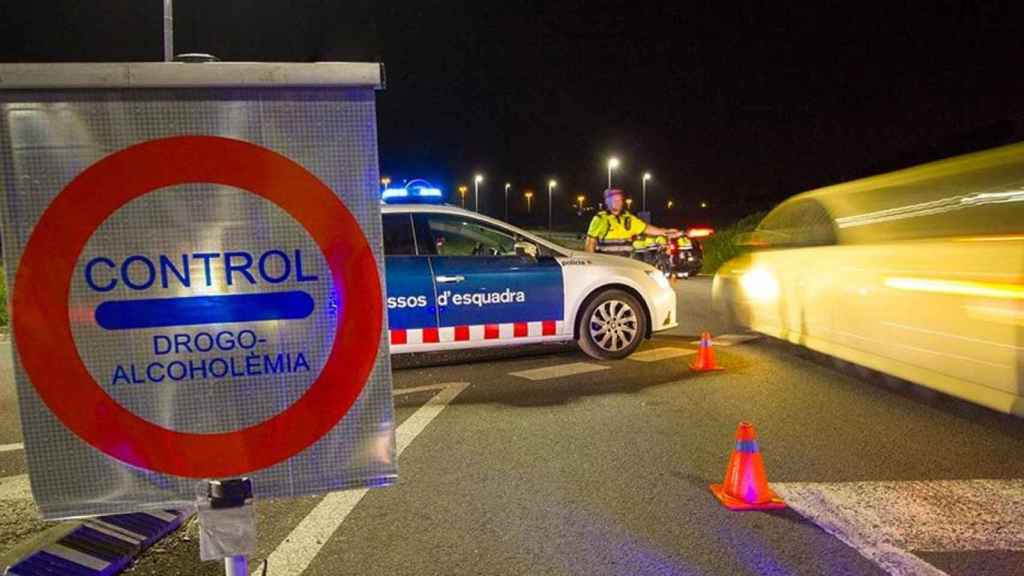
[253,383,469,576]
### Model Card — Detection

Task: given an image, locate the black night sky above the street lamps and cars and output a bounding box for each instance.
[0,0,1024,225]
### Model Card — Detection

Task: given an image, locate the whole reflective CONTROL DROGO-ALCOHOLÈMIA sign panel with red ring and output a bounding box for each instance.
[0,64,396,518]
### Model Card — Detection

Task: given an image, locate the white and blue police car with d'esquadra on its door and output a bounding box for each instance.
[382,181,677,360]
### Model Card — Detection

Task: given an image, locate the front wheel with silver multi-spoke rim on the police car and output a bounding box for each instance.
[580,290,647,360]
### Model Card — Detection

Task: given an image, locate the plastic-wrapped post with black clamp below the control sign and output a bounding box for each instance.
[197,478,256,576]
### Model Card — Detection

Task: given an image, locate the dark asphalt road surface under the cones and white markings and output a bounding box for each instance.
[0,278,1024,576]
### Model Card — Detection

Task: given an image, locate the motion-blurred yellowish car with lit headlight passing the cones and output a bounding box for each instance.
[713,143,1024,416]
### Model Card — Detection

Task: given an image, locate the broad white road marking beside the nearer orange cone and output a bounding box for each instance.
[772,480,1024,576]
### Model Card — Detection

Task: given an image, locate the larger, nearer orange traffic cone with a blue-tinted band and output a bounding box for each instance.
[711,422,785,510]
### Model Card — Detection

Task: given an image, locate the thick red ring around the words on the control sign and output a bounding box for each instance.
[11,136,383,478]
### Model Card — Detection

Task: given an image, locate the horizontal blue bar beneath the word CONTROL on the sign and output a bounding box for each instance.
[95,290,314,330]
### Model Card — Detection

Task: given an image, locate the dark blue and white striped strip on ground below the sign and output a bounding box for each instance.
[5,510,191,576]
